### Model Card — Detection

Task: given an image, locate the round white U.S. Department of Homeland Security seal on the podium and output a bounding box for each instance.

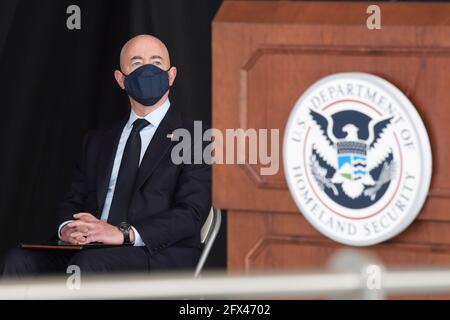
[283,73,431,246]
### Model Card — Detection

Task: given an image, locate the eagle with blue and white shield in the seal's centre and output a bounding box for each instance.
[309,109,395,202]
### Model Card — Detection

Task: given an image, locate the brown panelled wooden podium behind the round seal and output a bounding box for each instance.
[212,1,450,278]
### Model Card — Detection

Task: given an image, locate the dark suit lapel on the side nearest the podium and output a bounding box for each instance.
[135,106,181,190]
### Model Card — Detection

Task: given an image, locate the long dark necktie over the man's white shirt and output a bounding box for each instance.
[108,119,150,225]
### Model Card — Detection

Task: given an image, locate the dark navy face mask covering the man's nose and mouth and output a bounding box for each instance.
[124,64,169,106]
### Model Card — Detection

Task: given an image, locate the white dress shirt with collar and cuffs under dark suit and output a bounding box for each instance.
[58,99,170,246]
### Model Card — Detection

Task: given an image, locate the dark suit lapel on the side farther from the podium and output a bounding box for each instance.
[97,116,129,217]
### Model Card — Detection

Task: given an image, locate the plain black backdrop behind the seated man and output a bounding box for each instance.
[0,0,226,268]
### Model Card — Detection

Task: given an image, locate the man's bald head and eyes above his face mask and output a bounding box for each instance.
[120,34,170,74]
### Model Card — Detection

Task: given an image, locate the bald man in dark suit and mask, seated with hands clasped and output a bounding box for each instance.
[3,35,211,276]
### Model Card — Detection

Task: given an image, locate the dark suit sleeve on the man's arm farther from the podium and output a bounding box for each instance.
[57,133,90,225]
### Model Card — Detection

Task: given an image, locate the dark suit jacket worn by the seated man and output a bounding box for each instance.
[58,105,211,269]
